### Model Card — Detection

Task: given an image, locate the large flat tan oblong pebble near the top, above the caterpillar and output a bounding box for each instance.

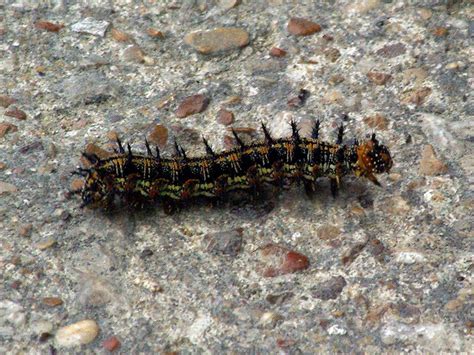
[184,27,249,54]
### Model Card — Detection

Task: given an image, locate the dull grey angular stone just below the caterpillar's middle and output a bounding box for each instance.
[204,228,243,257]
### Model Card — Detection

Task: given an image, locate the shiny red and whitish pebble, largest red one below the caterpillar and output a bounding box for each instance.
[260,243,309,277]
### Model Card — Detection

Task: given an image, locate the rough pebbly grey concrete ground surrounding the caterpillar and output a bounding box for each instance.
[0,0,474,353]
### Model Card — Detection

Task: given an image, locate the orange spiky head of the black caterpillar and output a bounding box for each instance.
[354,133,393,185]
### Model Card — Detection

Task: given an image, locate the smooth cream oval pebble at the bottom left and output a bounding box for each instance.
[55,319,99,348]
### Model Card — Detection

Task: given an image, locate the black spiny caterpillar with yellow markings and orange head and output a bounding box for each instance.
[71,120,393,211]
